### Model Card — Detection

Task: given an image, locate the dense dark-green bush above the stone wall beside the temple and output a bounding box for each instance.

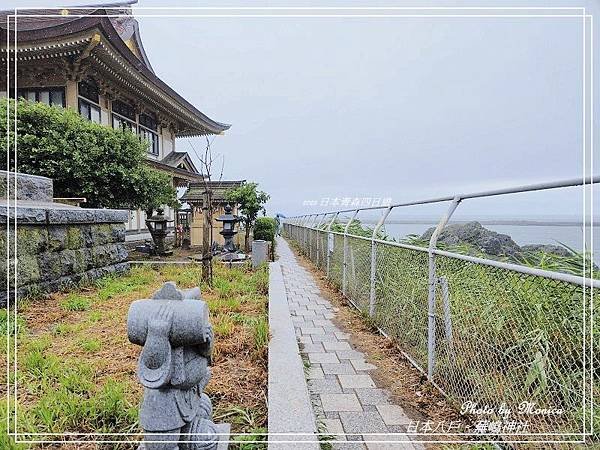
[0,99,177,211]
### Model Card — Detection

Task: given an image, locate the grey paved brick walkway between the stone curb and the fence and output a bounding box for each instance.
[277,237,423,450]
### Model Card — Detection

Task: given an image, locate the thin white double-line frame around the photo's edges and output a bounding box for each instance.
[6,5,595,444]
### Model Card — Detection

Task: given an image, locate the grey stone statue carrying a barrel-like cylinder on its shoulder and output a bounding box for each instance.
[127,282,225,450]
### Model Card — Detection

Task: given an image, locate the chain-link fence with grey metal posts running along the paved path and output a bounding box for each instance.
[284,176,600,442]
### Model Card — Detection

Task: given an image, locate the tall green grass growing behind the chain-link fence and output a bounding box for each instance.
[288,224,600,438]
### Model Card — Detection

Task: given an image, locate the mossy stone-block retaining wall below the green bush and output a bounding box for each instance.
[0,172,129,307]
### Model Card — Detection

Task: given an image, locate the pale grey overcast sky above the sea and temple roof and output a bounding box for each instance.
[9,0,600,221]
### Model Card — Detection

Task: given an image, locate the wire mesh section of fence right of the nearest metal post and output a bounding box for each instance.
[434,256,589,432]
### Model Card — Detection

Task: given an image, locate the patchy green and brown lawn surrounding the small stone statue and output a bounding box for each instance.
[0,256,269,442]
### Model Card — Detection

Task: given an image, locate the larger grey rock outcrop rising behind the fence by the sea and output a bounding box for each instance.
[421,222,521,256]
